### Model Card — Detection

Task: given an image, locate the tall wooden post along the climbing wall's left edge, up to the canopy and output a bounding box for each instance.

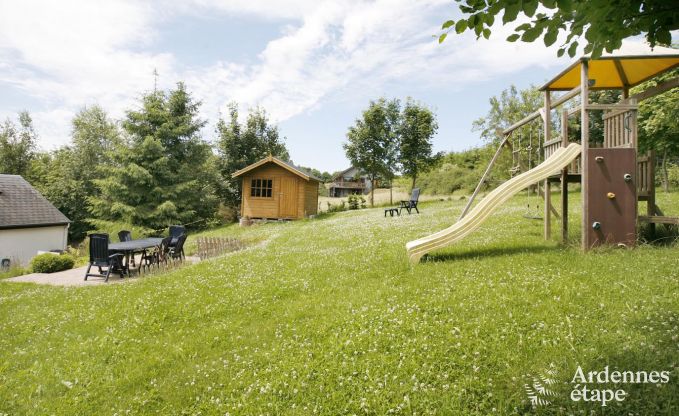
[580,59,590,250]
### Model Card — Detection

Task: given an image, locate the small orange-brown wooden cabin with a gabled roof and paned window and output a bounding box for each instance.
[232,156,321,219]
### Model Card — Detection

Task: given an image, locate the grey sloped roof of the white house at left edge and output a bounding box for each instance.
[0,174,71,229]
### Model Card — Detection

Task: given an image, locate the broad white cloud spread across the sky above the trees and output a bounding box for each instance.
[0,0,664,153]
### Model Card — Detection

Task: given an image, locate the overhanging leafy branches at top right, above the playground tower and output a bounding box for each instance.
[439,0,679,58]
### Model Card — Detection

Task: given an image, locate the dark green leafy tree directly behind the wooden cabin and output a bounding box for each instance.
[216,103,290,207]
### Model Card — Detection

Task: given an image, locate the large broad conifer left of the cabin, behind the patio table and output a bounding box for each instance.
[89,83,217,230]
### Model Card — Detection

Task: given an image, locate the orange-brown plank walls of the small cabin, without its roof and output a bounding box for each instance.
[241,163,318,219]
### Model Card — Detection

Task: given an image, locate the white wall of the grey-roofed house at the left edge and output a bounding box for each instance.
[0,225,68,266]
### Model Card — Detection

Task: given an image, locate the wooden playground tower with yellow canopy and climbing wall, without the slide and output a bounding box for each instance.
[460,54,679,250]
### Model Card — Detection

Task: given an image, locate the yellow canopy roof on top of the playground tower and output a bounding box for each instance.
[540,54,679,91]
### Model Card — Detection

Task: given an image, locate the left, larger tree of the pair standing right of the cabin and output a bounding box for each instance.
[343,98,401,206]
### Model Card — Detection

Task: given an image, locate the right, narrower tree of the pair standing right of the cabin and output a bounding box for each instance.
[399,100,441,188]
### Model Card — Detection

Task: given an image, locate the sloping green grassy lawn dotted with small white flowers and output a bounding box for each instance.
[0,190,679,415]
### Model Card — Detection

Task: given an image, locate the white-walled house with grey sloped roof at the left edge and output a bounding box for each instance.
[0,174,70,267]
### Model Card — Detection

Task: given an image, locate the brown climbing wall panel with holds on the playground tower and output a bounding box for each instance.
[585,148,637,248]
